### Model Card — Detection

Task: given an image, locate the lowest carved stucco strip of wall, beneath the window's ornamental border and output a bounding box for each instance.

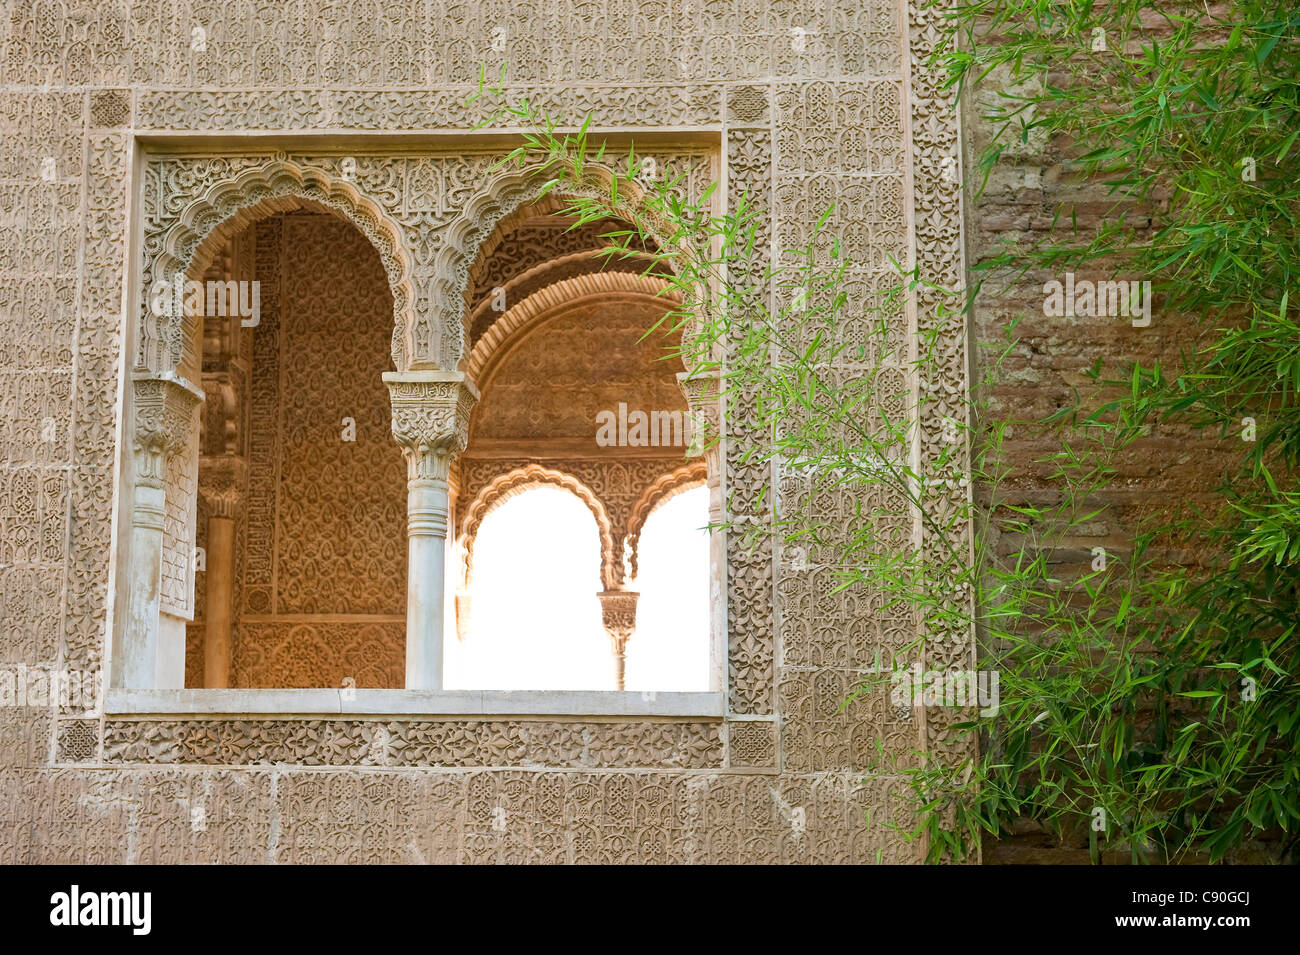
[0,767,909,864]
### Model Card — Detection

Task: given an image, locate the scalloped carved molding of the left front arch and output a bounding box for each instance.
[137,159,416,377]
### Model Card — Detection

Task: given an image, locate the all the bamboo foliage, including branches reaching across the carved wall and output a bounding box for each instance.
[470,0,1300,861]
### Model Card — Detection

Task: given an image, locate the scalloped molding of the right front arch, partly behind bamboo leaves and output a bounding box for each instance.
[436,164,686,368]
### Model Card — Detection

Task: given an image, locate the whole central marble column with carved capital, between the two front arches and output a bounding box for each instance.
[384,372,478,690]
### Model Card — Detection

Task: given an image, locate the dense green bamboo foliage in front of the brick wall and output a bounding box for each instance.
[923,0,1300,861]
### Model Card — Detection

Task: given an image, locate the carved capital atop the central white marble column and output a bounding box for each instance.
[384,372,478,481]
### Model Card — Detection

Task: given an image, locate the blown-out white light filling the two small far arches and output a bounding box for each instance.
[443,486,709,691]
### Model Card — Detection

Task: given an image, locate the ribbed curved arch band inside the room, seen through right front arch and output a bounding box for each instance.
[464,272,679,390]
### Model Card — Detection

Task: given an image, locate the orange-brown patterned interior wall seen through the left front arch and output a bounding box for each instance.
[186,213,406,689]
